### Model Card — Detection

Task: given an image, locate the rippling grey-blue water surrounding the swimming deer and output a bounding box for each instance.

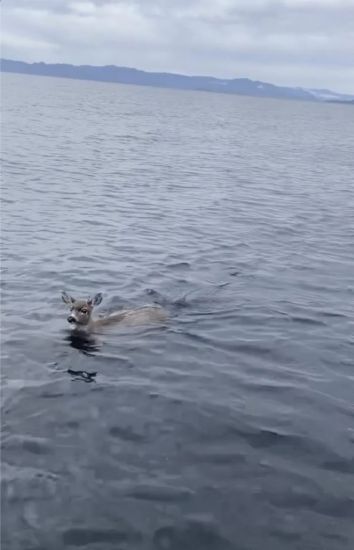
[2,75,354,550]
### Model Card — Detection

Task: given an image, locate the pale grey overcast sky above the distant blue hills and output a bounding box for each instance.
[1,0,354,94]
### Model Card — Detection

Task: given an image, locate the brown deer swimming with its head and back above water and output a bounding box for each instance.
[62,292,167,332]
